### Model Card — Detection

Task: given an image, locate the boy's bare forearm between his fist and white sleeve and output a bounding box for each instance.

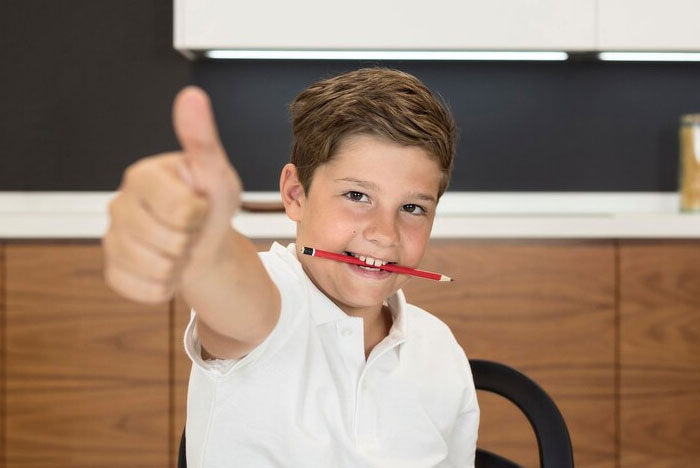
[183,229,280,358]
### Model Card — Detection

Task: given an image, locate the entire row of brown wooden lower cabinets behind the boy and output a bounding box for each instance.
[0,240,700,468]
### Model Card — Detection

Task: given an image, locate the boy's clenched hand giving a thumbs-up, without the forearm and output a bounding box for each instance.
[102,87,241,303]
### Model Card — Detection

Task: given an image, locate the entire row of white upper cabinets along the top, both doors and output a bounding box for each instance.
[174,0,700,54]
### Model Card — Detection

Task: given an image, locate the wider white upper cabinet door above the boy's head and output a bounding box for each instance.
[174,0,592,51]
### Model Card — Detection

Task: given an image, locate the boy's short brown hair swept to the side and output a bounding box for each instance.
[290,68,457,197]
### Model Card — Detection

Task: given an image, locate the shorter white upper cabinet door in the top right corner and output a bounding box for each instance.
[596,0,700,51]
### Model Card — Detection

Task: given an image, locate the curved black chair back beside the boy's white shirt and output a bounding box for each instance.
[470,359,574,468]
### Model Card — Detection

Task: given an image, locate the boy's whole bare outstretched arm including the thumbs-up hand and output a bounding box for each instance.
[102,87,280,358]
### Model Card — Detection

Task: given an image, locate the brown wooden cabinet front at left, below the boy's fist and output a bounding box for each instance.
[5,244,169,468]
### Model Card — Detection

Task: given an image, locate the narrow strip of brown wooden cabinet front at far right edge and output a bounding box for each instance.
[620,241,700,468]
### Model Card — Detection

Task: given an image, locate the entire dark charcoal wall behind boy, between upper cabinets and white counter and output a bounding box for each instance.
[0,0,700,191]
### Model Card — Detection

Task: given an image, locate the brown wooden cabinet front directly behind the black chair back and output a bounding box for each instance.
[404,240,615,468]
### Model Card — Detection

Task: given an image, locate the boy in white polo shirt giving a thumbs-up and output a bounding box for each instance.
[103,68,479,468]
